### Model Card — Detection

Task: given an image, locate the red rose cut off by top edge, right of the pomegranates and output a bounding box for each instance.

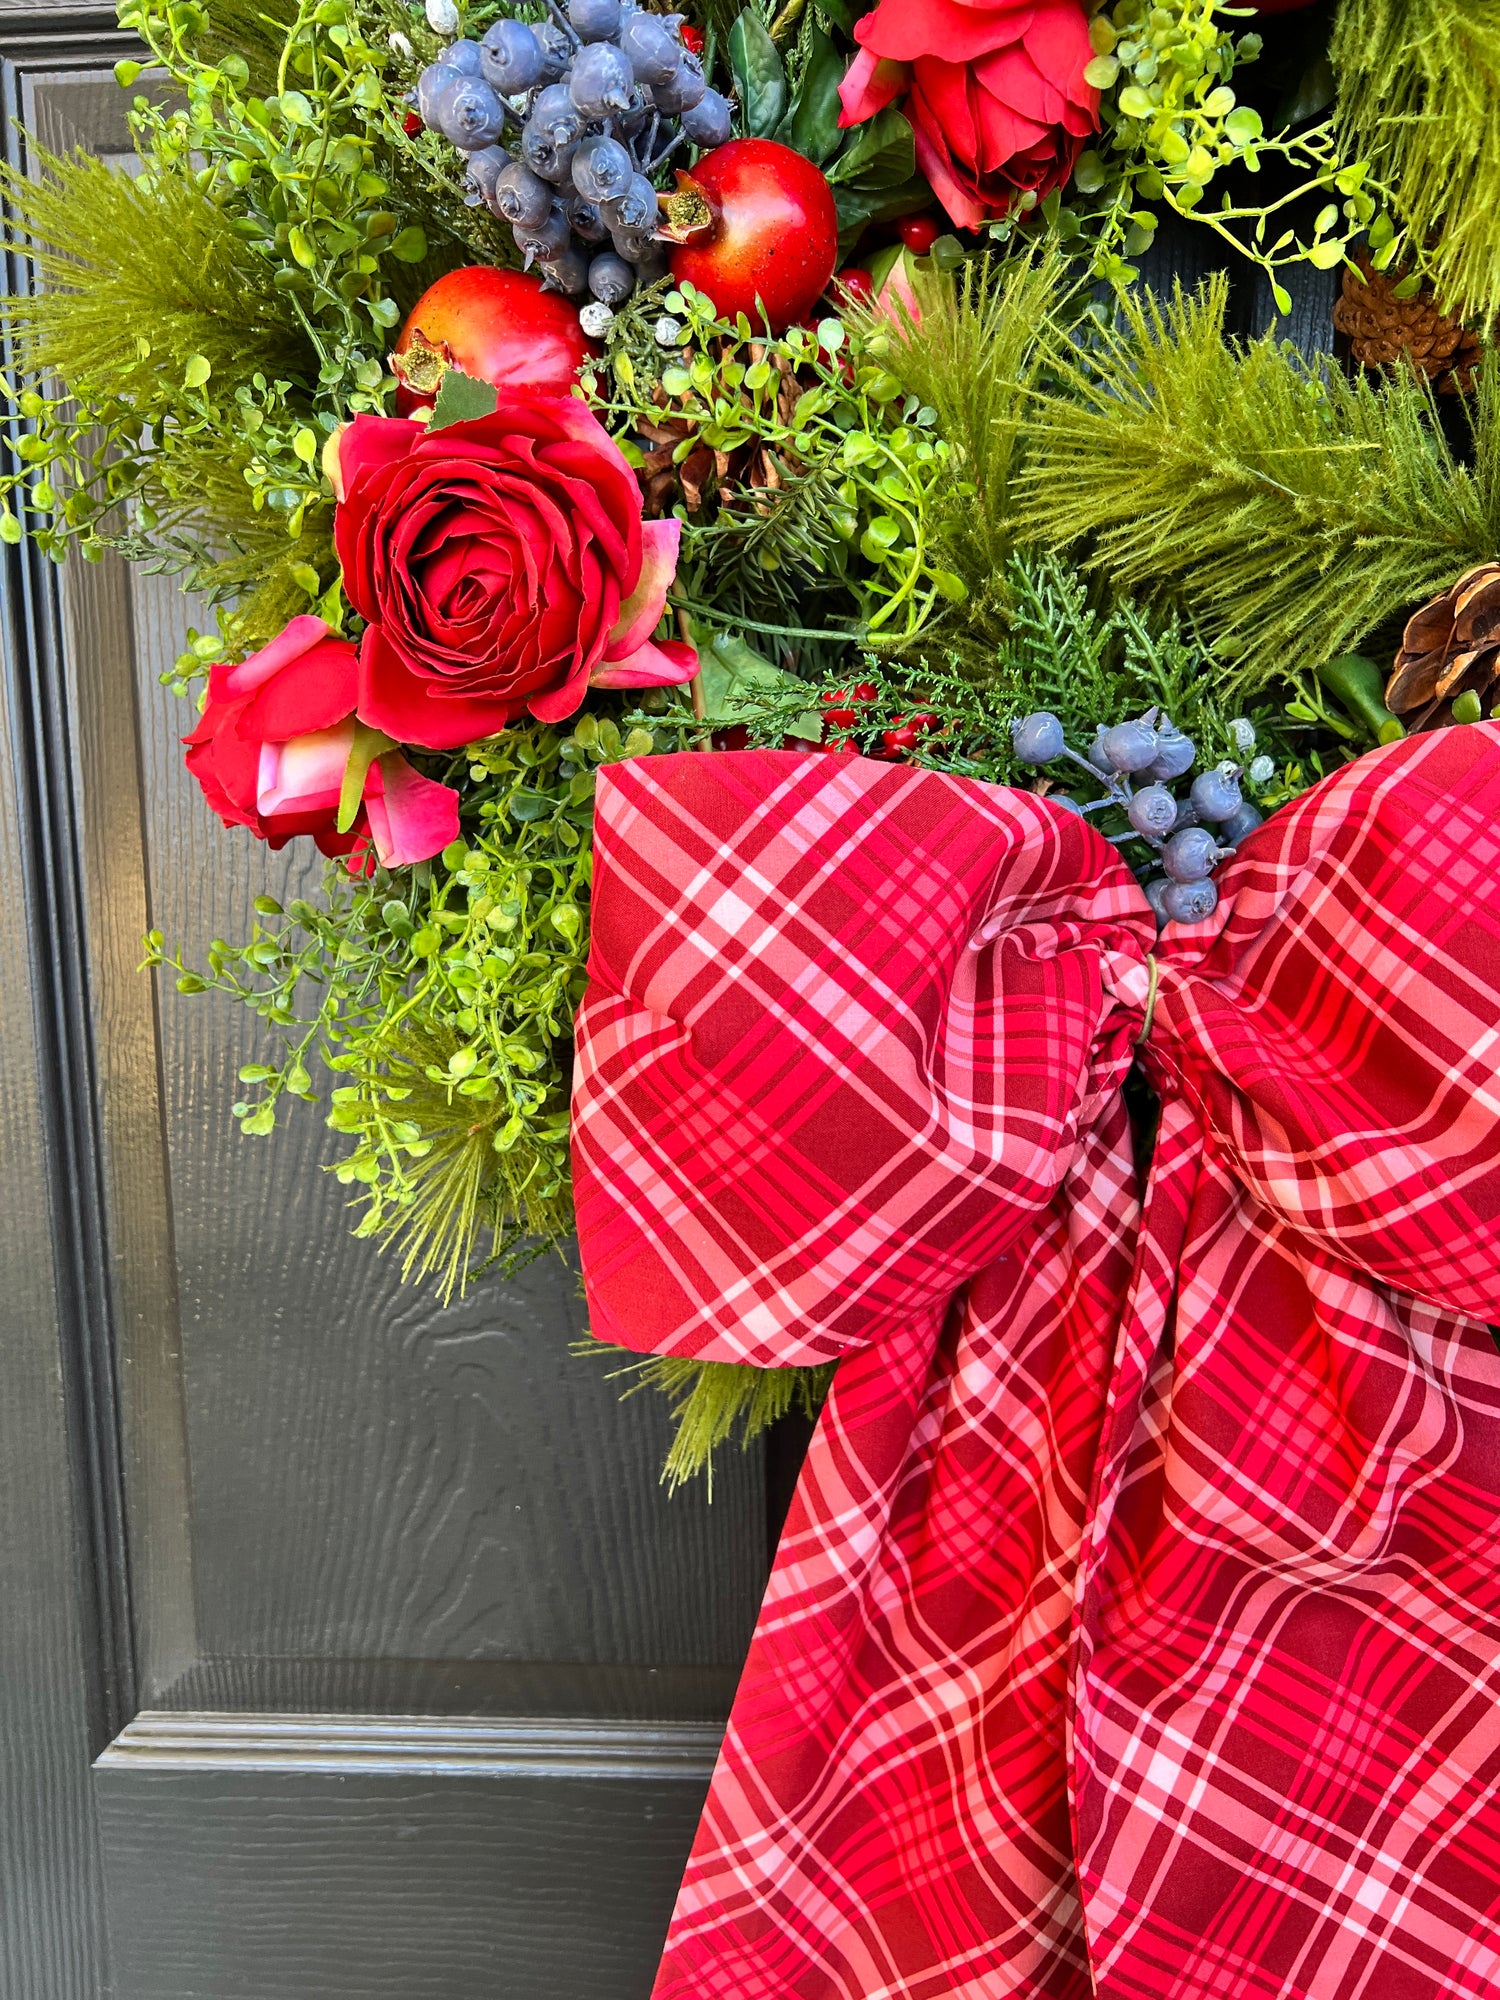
[838,0,1098,230]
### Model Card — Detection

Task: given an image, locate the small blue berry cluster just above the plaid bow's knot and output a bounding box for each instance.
[1010,708,1260,924]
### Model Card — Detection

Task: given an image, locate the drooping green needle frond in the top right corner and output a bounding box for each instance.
[1328,0,1500,320]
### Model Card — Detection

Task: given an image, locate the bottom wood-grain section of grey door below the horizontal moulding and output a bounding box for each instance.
[98,1764,704,2000]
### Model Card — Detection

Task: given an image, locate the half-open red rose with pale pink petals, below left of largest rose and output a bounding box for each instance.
[184,618,458,868]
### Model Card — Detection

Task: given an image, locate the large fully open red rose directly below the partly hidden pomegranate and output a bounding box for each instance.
[334,396,698,750]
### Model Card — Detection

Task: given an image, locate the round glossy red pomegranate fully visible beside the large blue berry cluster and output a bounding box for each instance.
[662,138,838,334]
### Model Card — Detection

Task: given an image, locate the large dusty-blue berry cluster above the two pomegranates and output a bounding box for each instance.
[414,0,730,332]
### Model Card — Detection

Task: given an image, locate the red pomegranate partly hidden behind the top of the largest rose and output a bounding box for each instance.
[392,264,598,416]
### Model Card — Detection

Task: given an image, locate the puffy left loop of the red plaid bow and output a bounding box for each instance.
[574,750,1154,1364]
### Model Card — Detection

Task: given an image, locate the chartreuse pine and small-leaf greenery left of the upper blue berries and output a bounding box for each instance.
[0,0,488,658]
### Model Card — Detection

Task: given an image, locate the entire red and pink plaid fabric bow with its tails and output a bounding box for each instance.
[574,726,1500,2000]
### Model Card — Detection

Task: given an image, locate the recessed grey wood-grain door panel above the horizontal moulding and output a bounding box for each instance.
[123,560,764,1708]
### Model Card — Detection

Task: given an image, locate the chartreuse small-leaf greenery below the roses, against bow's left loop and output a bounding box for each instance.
[148,714,640,1298]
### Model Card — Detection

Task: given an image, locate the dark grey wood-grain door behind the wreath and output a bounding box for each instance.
[0,10,768,2000]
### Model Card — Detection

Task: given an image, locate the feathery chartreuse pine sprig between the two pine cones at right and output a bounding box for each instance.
[1020,278,1500,688]
